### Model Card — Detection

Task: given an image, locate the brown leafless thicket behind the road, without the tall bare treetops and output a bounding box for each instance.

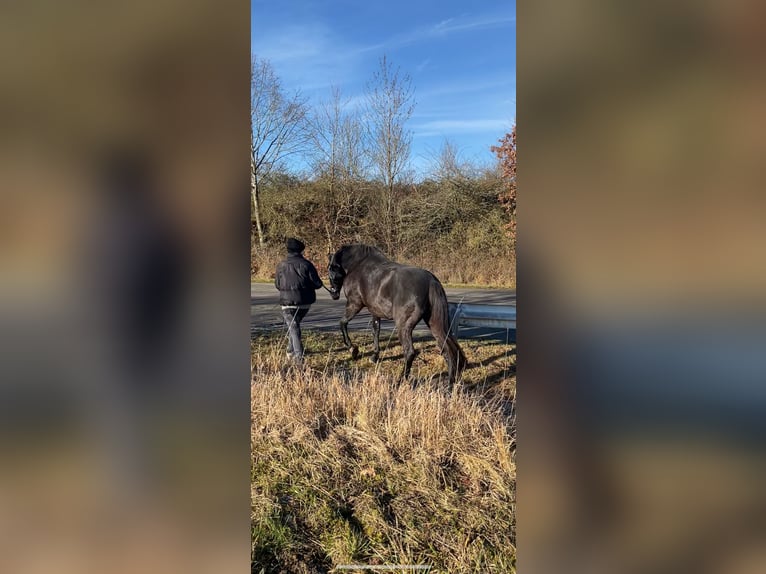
[253,164,515,286]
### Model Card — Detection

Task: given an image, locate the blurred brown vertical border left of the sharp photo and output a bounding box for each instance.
[0,0,250,574]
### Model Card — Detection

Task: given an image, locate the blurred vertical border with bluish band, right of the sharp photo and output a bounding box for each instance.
[517,0,766,574]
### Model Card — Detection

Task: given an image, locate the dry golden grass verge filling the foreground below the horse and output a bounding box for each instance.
[252,333,515,573]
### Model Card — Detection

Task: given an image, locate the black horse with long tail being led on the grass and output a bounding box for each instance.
[329,244,468,383]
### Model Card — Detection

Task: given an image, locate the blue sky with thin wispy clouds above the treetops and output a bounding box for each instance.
[251,0,516,178]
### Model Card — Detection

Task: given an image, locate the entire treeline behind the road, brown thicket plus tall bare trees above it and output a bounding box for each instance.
[251,57,516,286]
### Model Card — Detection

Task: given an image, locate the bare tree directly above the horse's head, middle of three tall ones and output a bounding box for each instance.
[312,87,368,250]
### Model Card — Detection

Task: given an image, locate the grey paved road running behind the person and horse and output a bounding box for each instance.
[250,283,516,340]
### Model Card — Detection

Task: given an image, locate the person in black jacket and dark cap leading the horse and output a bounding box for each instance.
[274,237,326,365]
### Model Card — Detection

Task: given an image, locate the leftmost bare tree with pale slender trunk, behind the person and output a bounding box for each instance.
[250,56,309,246]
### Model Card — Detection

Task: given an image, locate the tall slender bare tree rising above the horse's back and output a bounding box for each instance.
[367,56,415,255]
